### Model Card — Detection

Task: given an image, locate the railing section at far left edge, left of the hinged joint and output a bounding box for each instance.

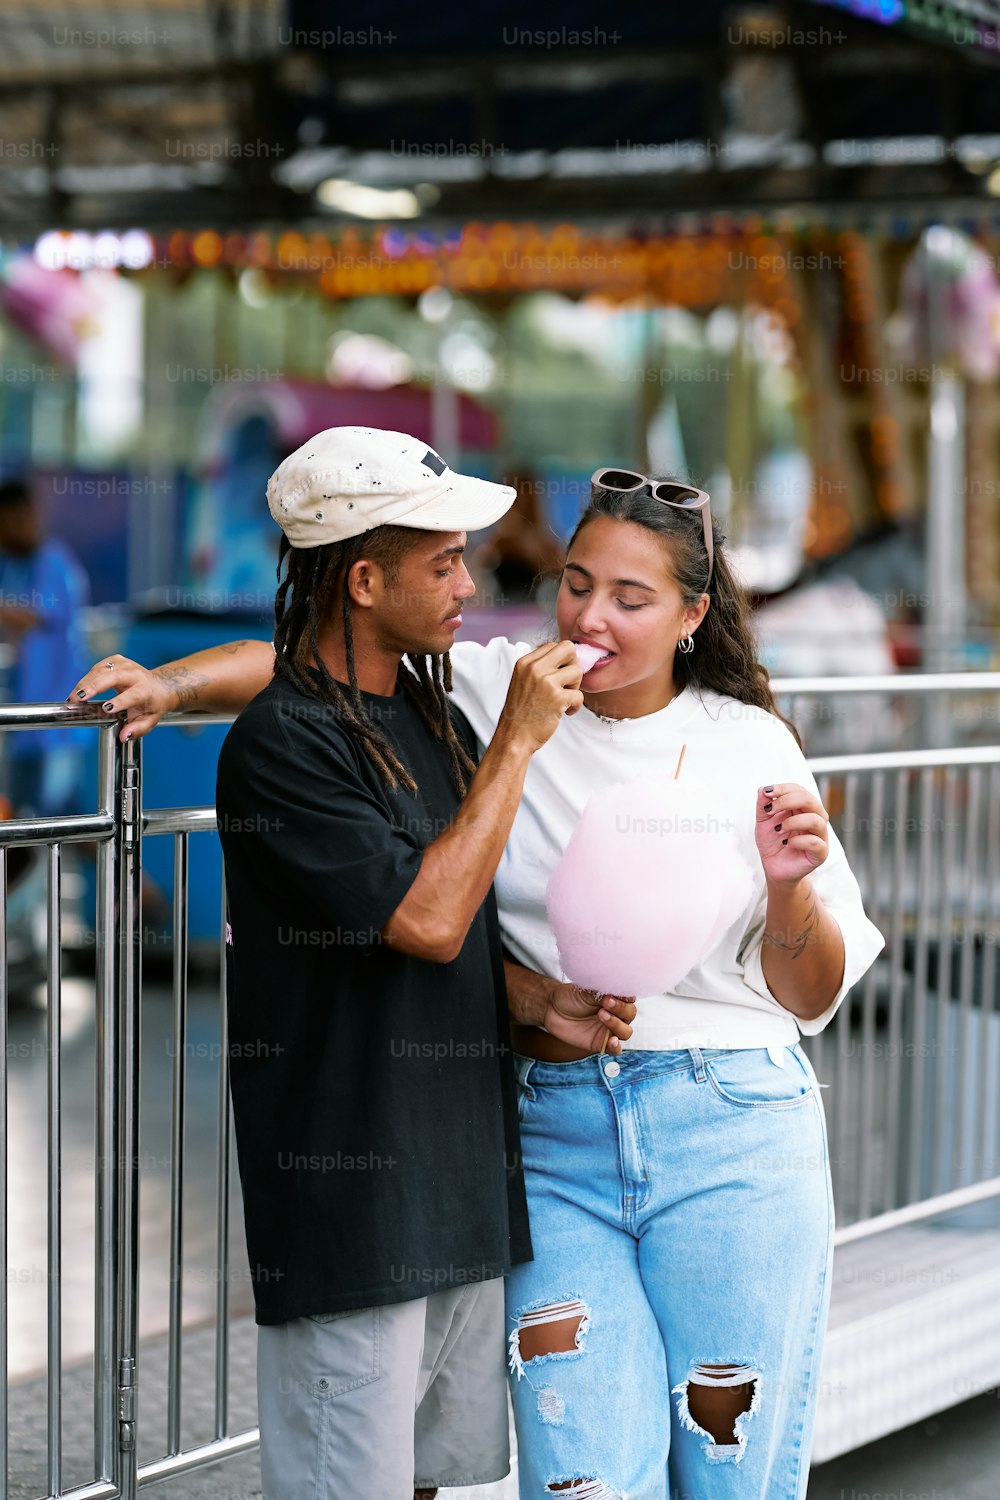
[0,704,123,1500]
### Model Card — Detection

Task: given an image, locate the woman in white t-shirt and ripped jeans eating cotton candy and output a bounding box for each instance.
[72,471,883,1500]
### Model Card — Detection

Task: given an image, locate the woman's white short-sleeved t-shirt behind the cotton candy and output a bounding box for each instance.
[451,638,885,1049]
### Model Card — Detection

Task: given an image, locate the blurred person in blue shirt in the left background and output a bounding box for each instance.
[0,479,90,816]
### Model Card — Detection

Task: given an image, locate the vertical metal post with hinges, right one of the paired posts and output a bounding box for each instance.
[115,741,142,1500]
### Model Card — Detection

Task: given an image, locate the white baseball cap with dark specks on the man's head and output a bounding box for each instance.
[267,428,517,548]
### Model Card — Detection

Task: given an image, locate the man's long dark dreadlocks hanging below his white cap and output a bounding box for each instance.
[274,527,475,797]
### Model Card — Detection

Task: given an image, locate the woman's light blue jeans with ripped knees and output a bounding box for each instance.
[505,1044,834,1500]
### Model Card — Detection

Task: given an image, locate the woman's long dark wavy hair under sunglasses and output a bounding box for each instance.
[567,474,802,749]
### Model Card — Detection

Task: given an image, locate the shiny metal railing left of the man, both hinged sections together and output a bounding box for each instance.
[0,704,258,1500]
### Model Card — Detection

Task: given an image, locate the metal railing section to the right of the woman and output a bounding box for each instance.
[771,672,1000,1244]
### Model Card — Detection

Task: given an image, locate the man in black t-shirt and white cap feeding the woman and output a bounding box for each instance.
[76,428,634,1500]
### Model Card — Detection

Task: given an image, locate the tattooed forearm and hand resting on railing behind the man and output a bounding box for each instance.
[66,641,274,740]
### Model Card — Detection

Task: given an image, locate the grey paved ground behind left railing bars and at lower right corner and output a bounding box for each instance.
[7,980,1000,1500]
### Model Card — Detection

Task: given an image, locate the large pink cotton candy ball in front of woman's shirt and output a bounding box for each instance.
[546,777,754,995]
